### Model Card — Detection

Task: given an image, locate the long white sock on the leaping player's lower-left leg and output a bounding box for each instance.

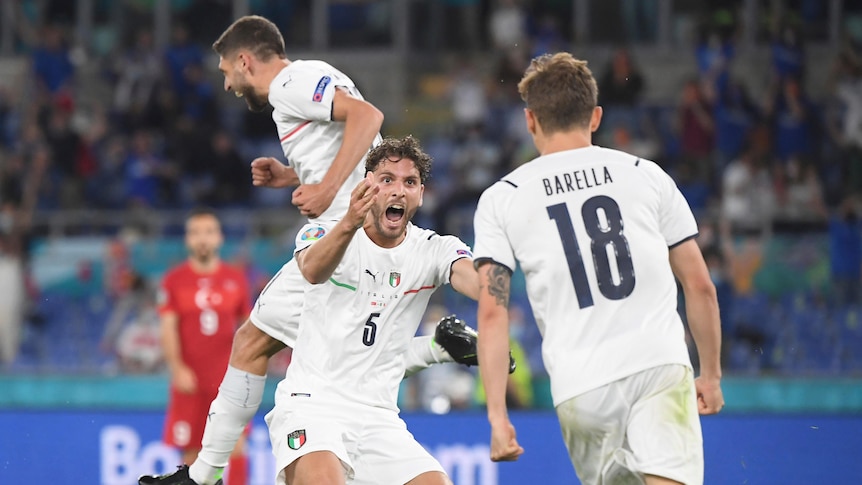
[189,366,266,485]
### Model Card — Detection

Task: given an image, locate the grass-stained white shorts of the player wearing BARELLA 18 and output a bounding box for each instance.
[557,364,703,485]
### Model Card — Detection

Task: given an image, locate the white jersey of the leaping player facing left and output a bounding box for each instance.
[269,60,380,221]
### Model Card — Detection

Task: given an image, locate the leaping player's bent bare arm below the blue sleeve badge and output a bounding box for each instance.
[292,89,383,217]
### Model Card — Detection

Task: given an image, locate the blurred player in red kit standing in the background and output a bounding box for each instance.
[159,209,251,485]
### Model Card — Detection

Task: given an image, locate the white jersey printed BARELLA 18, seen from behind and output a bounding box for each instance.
[474,146,697,405]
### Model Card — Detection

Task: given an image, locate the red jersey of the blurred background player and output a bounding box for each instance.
[159,261,251,390]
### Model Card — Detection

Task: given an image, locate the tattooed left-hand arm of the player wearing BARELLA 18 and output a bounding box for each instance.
[478,262,524,461]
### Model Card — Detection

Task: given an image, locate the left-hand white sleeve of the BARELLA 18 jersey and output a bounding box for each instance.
[473,183,516,272]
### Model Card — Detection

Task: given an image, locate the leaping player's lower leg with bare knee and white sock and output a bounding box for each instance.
[189,321,286,485]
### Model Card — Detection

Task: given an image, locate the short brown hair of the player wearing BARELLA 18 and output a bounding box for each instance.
[518,52,599,133]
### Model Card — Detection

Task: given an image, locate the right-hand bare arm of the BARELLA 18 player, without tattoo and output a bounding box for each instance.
[670,239,724,414]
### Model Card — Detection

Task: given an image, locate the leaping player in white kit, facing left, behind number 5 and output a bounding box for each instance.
[139,16,476,485]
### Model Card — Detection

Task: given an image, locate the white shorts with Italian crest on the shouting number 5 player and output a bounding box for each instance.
[266,395,445,485]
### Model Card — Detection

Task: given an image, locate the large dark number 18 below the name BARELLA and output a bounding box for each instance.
[547,195,635,308]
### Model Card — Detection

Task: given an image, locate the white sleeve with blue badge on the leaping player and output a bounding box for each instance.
[269,70,337,121]
